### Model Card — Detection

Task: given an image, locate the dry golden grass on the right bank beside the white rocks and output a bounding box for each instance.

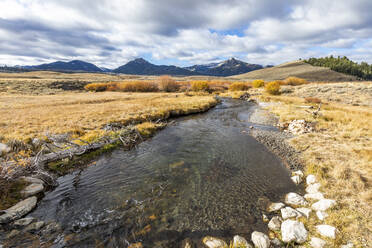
[262,93,372,247]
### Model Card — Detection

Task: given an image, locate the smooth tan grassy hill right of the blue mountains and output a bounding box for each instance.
[230,61,356,82]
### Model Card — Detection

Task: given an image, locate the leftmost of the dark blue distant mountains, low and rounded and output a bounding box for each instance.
[24,60,102,72]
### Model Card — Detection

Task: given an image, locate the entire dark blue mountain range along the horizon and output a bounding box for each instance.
[15,58,264,77]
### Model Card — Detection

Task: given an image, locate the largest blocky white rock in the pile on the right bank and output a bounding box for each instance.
[281,220,307,244]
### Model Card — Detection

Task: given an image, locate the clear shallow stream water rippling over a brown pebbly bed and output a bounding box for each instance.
[31,99,295,247]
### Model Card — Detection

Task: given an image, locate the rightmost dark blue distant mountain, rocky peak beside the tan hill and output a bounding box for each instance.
[185,58,263,77]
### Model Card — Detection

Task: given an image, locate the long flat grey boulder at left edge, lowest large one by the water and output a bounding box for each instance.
[0,196,37,224]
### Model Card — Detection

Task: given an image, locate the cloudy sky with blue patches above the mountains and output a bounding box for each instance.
[0,0,372,68]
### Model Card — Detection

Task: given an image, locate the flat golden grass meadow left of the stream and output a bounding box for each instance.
[0,92,216,140]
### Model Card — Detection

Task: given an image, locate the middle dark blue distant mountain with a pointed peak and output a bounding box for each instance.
[113,58,200,76]
